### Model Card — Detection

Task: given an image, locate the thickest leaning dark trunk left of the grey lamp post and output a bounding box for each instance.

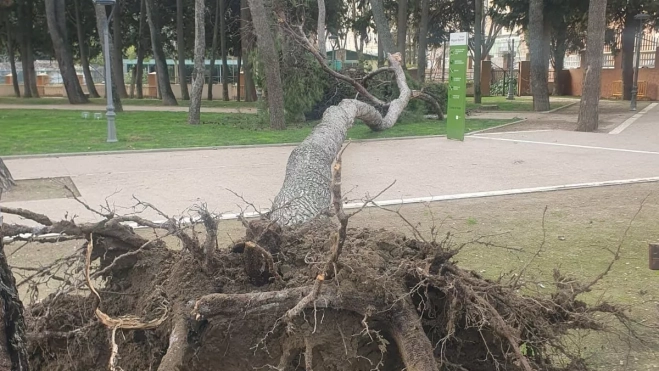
[45,0,89,104]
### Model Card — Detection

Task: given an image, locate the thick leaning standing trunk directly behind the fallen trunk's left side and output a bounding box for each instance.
[249,0,286,130]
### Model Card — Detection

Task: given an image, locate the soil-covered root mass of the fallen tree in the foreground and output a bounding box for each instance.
[26,218,620,371]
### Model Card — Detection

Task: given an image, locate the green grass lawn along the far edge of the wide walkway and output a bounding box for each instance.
[0,110,508,155]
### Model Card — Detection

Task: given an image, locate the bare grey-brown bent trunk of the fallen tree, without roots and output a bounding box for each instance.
[269,54,412,226]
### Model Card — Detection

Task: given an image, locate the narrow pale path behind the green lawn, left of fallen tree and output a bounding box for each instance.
[0,104,256,114]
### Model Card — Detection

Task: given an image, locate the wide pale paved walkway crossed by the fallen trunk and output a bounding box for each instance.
[5,101,659,224]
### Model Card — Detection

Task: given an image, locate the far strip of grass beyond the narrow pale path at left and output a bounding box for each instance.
[0,95,256,108]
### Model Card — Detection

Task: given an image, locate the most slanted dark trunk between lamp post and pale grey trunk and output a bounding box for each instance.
[145,0,178,106]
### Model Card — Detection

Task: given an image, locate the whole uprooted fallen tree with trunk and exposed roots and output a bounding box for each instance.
[0,29,640,371]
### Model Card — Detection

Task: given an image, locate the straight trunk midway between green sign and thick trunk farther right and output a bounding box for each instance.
[529,0,549,111]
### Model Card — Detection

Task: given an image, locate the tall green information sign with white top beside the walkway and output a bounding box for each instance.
[446,32,469,140]
